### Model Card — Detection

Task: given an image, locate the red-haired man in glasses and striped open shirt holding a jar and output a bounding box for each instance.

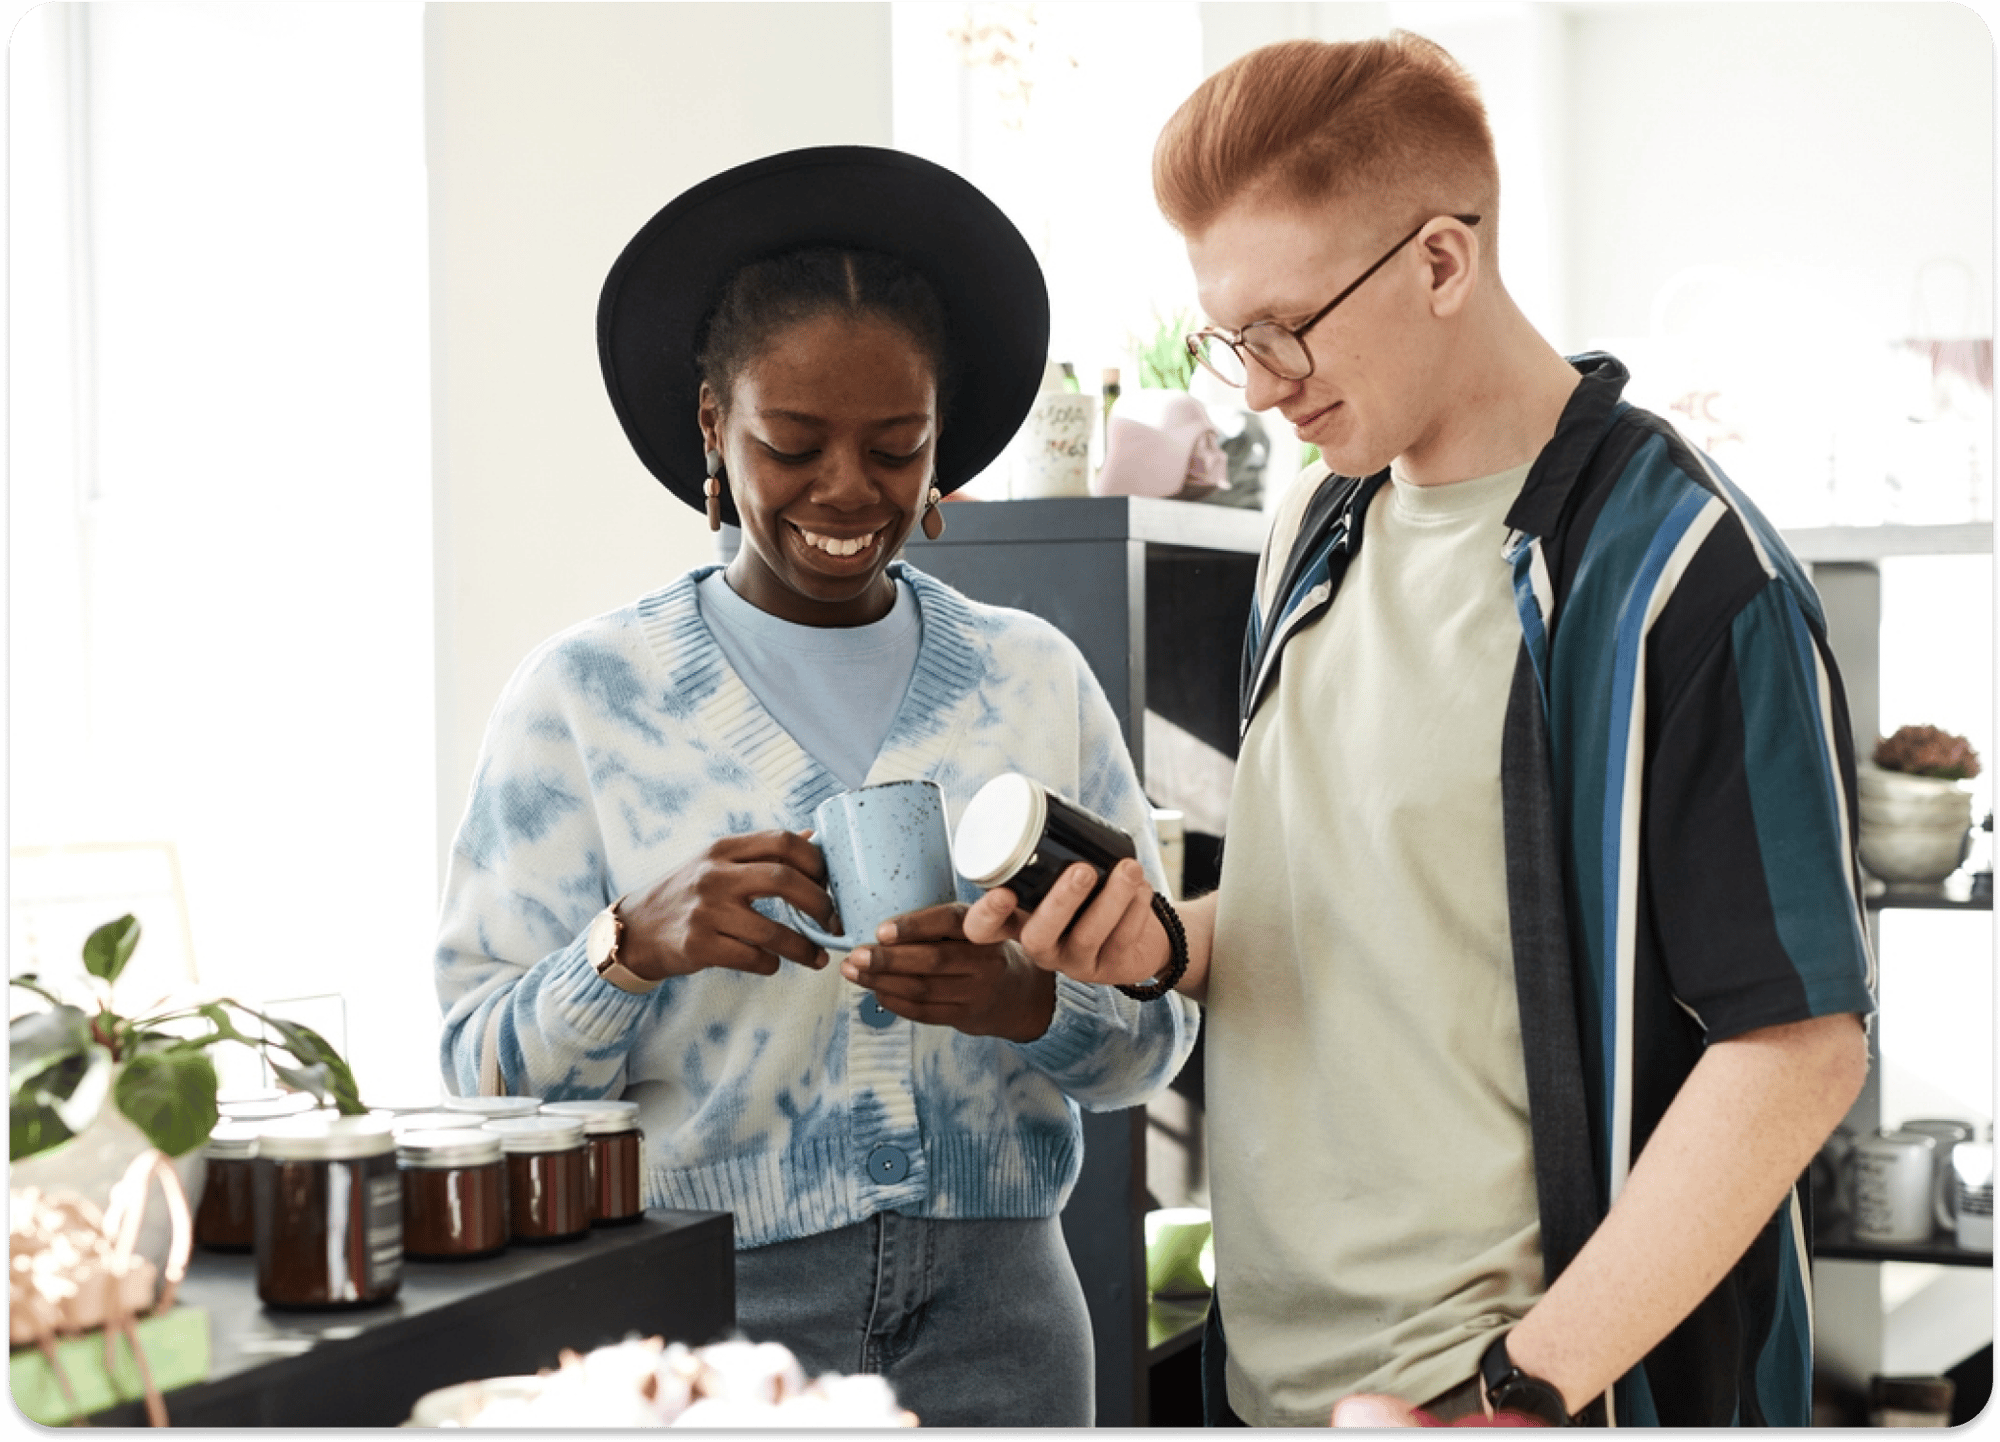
[966,34,1872,1428]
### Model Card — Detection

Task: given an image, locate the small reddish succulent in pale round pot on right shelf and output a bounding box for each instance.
[1860,726,1980,886]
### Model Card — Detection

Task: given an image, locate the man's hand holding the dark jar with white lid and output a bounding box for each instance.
[964,860,1168,986]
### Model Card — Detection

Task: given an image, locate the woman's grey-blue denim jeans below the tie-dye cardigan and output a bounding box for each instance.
[736,1212,1096,1428]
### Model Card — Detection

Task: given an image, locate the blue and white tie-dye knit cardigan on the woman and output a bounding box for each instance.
[436,564,1198,1246]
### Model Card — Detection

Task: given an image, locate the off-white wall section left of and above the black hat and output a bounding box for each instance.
[426,0,890,856]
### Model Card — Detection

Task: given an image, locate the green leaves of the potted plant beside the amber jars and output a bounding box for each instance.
[6,916,368,1164]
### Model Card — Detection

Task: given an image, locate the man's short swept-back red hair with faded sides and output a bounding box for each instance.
[1152,30,1500,244]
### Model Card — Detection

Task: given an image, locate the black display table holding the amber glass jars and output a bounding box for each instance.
[92,1212,736,1432]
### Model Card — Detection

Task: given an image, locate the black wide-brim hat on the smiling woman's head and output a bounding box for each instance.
[598,146,1048,524]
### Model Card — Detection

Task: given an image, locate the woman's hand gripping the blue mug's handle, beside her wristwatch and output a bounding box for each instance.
[618,832,834,982]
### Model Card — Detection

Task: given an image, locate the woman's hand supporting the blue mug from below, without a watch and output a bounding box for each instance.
[840,902,1056,1042]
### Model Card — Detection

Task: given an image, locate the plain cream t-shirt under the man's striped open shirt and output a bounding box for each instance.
[1206,466,1542,1426]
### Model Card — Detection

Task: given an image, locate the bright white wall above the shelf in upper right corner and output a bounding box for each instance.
[1566,0,1994,344]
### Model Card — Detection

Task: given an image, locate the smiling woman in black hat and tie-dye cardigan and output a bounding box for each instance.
[438,148,1196,1426]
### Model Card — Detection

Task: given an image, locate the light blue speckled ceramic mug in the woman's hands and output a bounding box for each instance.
[752,782,958,952]
